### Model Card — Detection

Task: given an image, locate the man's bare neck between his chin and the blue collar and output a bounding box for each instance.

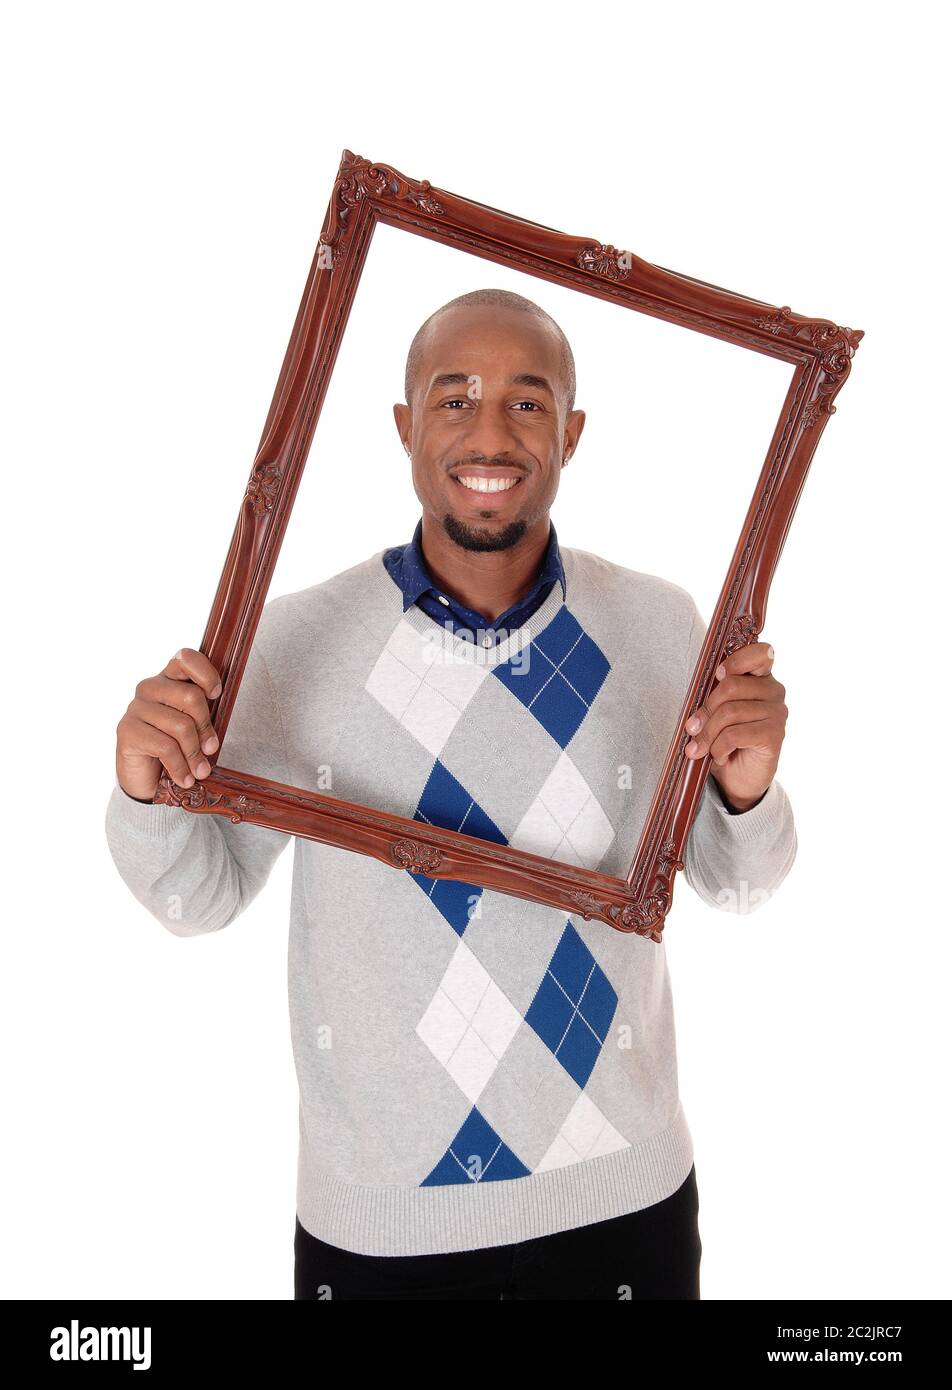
[420,512,549,623]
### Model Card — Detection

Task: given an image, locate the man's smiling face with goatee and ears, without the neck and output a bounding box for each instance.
[393,304,585,550]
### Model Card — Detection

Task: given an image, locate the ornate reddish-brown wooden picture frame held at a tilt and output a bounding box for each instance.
[153,150,863,941]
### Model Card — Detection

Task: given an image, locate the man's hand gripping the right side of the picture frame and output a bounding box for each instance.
[684,642,788,810]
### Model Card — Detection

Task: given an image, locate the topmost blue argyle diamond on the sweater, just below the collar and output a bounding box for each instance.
[493,606,612,748]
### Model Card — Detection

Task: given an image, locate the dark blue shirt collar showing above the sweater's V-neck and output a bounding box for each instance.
[384,517,566,646]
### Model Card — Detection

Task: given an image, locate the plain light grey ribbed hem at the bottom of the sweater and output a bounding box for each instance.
[297,1102,694,1255]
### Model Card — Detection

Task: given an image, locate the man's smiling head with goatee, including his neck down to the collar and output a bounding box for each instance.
[393,291,585,642]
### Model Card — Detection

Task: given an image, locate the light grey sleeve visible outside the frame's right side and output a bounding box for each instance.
[684,607,796,912]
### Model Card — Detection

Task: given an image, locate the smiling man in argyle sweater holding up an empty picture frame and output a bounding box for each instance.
[107,291,796,1300]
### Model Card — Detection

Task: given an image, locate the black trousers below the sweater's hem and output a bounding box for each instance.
[295,1166,702,1302]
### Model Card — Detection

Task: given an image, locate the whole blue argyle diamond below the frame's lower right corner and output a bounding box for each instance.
[525,922,618,1088]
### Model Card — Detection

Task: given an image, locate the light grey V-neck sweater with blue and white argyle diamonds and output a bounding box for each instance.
[106,546,796,1255]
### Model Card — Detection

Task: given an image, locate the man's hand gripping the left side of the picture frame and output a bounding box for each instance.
[115,646,221,801]
